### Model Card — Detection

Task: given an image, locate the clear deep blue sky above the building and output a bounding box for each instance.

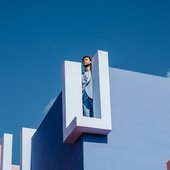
[0,0,170,163]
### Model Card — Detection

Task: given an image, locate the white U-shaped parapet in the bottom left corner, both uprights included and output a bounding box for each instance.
[0,128,36,170]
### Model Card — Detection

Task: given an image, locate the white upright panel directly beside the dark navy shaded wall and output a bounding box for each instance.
[21,128,36,170]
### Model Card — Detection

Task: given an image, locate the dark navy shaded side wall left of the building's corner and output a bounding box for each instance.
[31,93,83,170]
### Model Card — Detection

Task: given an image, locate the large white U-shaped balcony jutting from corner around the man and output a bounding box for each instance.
[62,50,112,144]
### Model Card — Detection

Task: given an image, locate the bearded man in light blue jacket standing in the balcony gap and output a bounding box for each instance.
[82,56,94,117]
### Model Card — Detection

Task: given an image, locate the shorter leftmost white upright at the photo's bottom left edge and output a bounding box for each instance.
[0,134,13,170]
